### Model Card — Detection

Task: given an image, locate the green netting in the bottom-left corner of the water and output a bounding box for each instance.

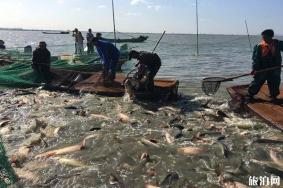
[0,139,17,188]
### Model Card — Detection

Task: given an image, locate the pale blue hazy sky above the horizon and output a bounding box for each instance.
[0,0,283,35]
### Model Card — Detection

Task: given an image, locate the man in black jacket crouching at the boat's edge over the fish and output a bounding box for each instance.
[125,50,161,97]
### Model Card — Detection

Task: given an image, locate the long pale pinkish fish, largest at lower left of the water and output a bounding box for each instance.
[35,135,96,158]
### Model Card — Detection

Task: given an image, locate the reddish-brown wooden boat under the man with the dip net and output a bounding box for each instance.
[227,85,283,131]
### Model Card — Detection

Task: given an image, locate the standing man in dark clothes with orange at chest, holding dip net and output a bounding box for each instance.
[246,29,283,103]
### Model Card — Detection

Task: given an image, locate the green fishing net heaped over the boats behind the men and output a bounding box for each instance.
[0,46,128,88]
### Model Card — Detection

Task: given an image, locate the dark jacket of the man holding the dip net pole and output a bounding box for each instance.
[252,39,283,71]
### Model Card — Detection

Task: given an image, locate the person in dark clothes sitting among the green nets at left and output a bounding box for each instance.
[32,41,51,83]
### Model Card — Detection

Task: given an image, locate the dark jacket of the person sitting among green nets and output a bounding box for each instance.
[32,48,51,68]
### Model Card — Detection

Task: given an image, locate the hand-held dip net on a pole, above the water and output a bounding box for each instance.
[202,77,224,95]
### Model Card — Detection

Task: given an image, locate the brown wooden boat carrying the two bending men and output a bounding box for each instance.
[47,69,179,100]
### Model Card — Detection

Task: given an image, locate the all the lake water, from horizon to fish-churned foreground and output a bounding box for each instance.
[0,31,283,188]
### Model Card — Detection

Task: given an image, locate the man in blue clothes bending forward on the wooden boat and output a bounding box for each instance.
[92,37,120,83]
